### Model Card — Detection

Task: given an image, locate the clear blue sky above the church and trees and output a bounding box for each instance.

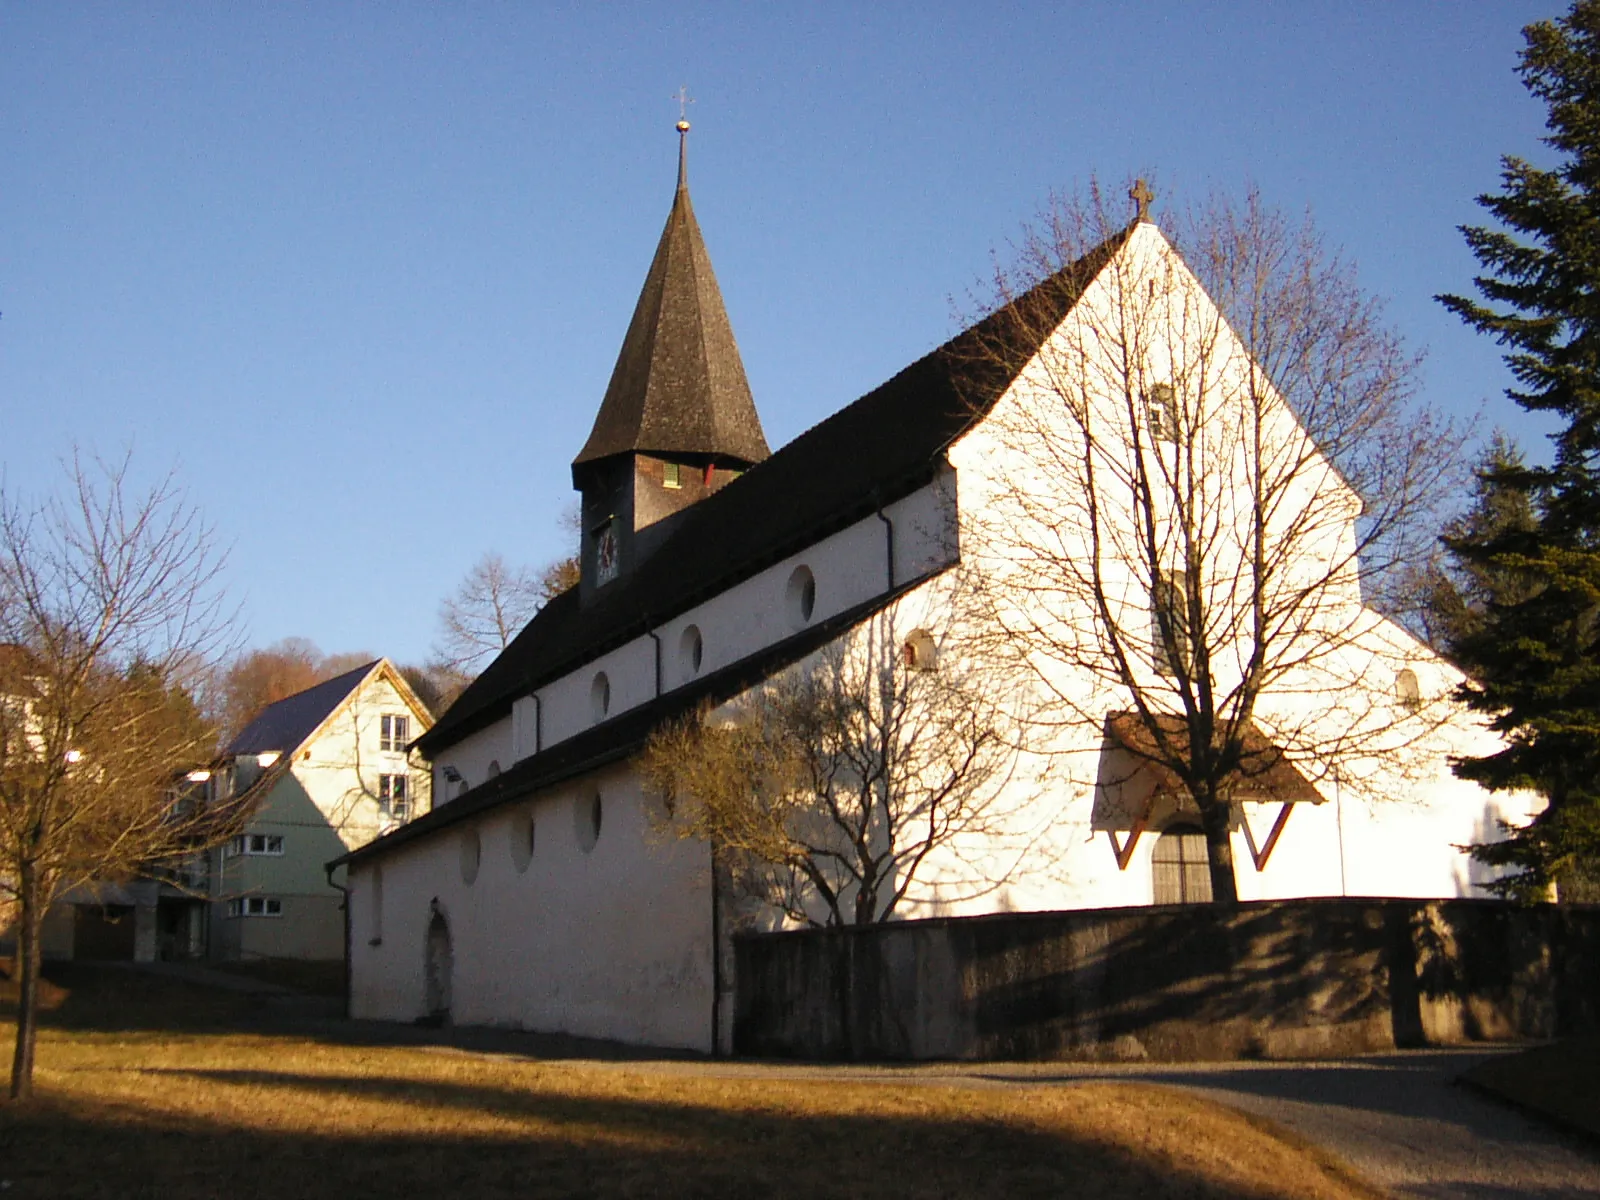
[0,0,1562,661]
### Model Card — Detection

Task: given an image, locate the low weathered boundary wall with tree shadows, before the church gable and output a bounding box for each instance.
[734,899,1600,1061]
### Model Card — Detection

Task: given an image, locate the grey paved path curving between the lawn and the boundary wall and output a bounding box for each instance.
[528,1050,1600,1200]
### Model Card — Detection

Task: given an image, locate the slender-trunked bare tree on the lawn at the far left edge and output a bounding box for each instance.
[0,459,237,1099]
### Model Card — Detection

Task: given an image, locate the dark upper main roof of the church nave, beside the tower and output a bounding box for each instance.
[418,225,1125,755]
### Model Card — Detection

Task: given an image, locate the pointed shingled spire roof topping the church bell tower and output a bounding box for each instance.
[573,133,771,483]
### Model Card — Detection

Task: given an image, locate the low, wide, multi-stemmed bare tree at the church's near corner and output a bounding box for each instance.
[640,613,1018,925]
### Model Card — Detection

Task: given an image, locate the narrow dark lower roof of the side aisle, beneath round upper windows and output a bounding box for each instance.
[337,571,939,870]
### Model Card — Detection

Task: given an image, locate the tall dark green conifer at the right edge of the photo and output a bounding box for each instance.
[1440,0,1600,896]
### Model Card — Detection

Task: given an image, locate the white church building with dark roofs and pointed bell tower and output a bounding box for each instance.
[336,123,1526,1051]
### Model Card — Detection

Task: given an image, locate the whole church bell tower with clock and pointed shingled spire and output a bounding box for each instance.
[573,120,771,603]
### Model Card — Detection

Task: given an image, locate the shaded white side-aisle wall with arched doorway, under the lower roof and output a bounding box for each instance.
[350,768,726,1050]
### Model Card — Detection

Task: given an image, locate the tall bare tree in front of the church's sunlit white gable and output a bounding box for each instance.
[958,186,1462,902]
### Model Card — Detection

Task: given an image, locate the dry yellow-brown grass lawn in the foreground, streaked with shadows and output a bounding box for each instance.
[0,982,1373,1200]
